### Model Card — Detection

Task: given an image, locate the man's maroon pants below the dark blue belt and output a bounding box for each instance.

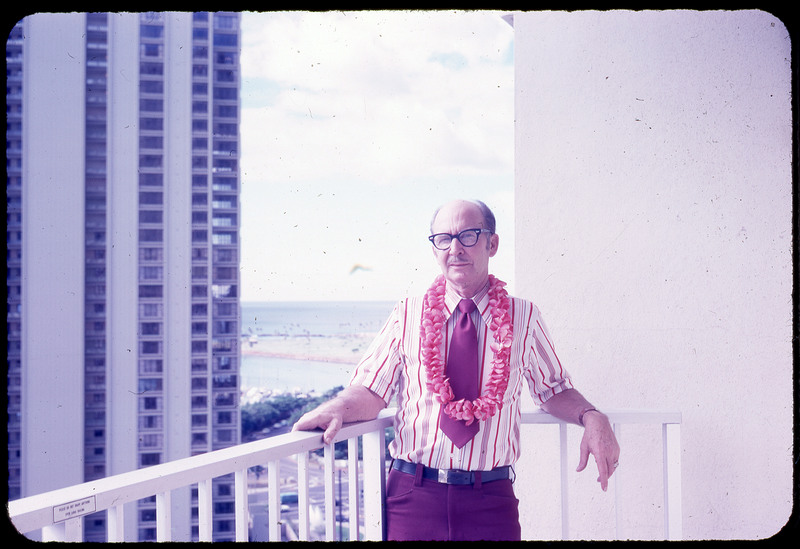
[385,466,520,541]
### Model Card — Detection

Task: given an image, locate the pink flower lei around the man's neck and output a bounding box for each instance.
[420,275,513,425]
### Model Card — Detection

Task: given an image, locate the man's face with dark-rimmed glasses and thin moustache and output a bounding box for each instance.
[431,201,498,298]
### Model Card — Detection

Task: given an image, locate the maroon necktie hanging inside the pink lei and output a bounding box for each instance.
[439,299,480,448]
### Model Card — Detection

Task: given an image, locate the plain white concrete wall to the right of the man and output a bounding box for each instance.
[513,11,792,539]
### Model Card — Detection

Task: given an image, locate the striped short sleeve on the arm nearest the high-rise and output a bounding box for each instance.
[350,301,403,404]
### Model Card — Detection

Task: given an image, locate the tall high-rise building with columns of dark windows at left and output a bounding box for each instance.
[6,12,240,540]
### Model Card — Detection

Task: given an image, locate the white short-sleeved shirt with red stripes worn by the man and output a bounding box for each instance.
[350,284,573,471]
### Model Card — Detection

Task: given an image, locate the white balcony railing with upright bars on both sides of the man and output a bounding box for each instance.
[8,408,681,541]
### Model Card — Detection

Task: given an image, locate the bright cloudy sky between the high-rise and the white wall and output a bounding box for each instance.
[240,11,514,301]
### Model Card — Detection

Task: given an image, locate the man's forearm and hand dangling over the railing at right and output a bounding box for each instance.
[542,389,619,491]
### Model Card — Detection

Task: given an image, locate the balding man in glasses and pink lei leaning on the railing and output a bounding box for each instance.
[294,200,619,540]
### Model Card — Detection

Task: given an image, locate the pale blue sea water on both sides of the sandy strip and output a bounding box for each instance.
[240,301,394,393]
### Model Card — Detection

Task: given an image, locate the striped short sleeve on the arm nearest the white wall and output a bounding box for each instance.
[525,305,573,406]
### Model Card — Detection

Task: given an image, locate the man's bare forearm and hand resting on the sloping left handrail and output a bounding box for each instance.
[292,385,386,444]
